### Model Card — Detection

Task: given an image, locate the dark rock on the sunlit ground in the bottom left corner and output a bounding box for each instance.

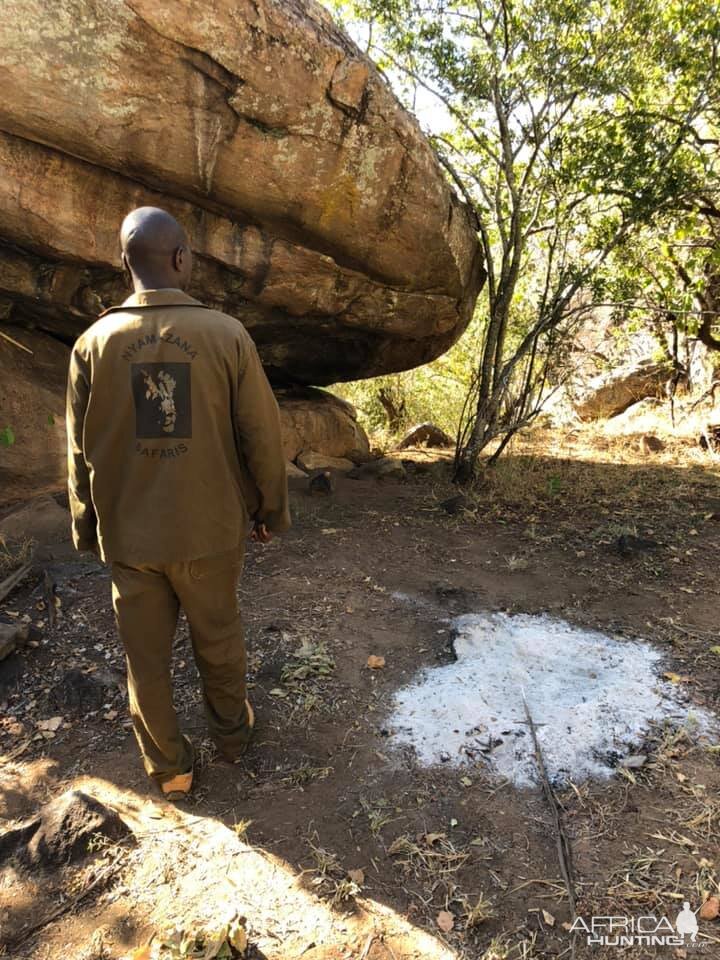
[0,790,130,867]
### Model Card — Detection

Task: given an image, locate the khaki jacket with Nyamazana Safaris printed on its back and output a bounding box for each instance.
[67,290,290,564]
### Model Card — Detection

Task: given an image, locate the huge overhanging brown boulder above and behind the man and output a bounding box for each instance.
[0,0,484,384]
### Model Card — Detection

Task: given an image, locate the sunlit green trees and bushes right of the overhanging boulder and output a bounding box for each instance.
[331,0,720,457]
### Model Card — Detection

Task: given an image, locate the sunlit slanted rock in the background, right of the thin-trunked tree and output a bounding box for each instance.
[574,361,673,420]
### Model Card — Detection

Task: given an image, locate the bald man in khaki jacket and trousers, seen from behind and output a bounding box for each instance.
[67,207,290,799]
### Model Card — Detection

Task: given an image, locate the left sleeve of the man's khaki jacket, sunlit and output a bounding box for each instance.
[65,344,97,550]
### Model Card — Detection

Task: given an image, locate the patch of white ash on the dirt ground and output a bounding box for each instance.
[390,613,717,786]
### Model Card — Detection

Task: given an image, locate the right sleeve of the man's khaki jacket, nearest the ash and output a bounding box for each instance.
[235,333,290,533]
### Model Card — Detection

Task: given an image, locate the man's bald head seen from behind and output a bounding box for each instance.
[120,207,192,290]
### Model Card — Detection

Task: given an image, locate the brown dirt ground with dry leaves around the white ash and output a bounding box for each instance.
[0,430,720,960]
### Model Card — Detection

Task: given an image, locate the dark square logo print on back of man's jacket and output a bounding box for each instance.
[130,363,192,440]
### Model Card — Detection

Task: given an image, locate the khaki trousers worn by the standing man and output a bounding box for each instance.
[112,547,251,783]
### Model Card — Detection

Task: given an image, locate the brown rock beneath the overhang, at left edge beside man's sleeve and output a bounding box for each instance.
[0,326,70,509]
